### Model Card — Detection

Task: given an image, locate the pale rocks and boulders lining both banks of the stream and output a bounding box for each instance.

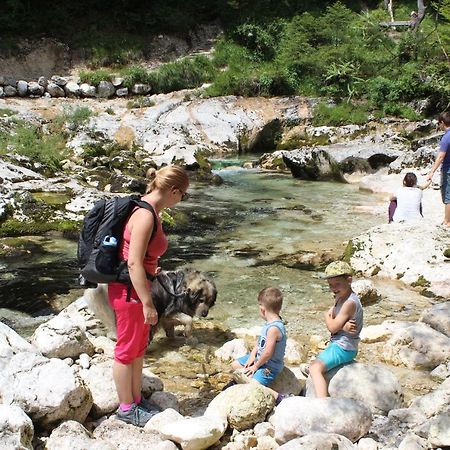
[0,92,450,450]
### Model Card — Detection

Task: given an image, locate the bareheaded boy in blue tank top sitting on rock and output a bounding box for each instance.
[231,287,287,403]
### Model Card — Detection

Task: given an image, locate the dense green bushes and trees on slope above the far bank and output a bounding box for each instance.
[0,0,450,117]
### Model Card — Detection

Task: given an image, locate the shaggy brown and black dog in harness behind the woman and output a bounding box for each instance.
[84,269,217,337]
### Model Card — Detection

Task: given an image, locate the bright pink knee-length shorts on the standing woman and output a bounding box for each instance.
[108,283,150,364]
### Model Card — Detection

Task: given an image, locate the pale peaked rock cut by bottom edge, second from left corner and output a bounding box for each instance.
[45,420,117,450]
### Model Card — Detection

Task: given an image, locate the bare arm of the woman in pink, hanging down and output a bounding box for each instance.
[128,208,158,325]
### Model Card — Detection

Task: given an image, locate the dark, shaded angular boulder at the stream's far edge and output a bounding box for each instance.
[283,147,343,181]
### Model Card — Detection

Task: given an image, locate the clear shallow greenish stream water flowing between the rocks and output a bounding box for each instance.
[0,161,438,411]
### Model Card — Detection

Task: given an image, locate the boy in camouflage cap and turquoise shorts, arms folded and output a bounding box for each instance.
[309,261,363,398]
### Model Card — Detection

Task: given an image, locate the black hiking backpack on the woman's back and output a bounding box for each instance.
[77,195,157,287]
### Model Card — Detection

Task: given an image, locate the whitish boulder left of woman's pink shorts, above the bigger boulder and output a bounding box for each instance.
[31,315,94,359]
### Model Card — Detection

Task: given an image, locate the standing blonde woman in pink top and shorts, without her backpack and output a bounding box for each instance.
[108,166,189,427]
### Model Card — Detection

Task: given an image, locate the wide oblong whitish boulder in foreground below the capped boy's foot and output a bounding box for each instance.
[270,397,372,444]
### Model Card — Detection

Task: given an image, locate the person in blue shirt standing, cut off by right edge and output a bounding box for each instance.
[427,112,450,227]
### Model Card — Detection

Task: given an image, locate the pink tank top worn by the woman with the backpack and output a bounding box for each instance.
[119,205,168,275]
